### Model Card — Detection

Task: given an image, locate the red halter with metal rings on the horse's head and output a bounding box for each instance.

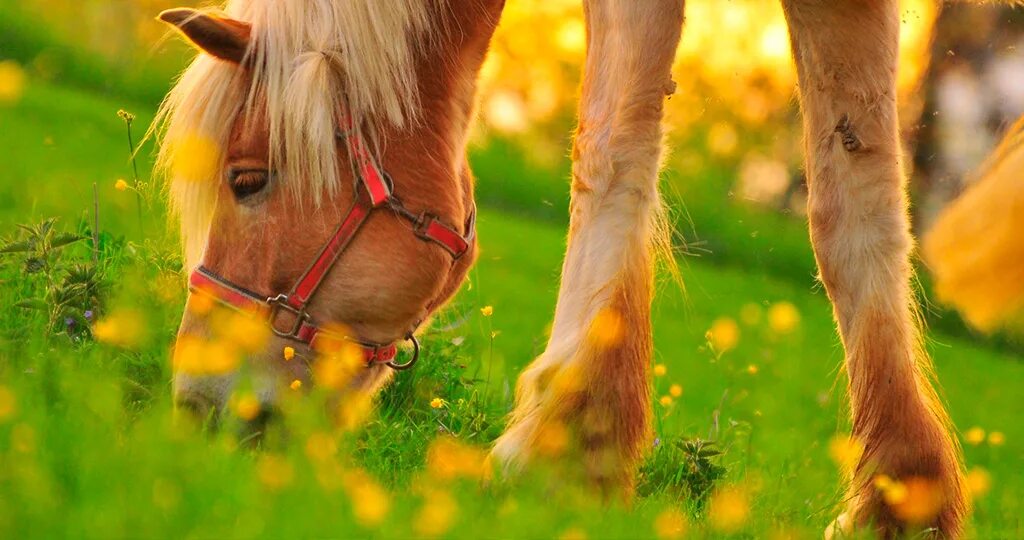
[188,105,476,370]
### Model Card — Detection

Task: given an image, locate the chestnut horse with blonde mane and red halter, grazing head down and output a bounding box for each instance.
[155,0,967,537]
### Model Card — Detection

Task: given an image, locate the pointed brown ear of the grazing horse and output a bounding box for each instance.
[160,7,252,64]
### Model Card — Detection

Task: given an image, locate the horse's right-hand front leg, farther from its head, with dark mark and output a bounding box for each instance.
[783,0,966,538]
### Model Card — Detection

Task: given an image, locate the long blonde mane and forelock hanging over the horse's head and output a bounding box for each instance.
[154,0,443,268]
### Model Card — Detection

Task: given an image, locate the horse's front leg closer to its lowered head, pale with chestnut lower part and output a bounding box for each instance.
[493,0,683,493]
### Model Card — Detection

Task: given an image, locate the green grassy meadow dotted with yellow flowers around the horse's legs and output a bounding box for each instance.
[0,2,1024,539]
